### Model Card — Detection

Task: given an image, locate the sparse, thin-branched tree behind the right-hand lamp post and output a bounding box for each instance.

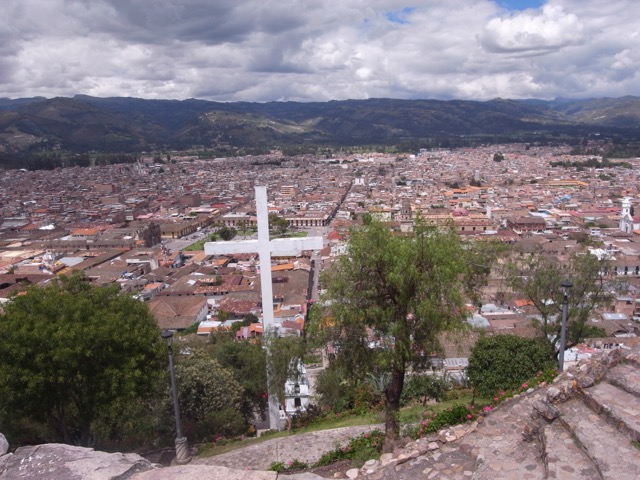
[506,252,614,356]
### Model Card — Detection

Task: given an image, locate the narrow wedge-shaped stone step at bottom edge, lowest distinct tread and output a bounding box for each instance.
[543,422,602,480]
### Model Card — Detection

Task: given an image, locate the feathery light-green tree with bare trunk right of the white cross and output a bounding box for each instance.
[323,221,478,447]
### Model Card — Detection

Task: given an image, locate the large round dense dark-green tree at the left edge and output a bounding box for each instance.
[0,274,166,446]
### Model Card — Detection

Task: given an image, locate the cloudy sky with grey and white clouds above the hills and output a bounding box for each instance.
[0,0,640,101]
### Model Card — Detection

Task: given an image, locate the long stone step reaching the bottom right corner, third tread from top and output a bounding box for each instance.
[557,398,640,480]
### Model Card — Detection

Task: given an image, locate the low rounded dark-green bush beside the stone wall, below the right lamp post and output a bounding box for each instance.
[468,335,555,397]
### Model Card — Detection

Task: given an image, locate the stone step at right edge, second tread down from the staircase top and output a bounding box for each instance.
[581,382,640,441]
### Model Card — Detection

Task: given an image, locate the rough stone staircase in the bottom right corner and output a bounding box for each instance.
[463,349,640,480]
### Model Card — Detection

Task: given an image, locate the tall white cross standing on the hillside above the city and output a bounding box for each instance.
[204,186,323,430]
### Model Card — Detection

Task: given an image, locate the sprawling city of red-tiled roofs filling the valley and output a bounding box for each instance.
[0,144,640,343]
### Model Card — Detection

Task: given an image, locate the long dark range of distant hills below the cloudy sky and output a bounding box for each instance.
[0,95,640,160]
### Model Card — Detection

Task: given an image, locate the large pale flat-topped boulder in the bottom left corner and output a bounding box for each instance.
[0,443,156,480]
